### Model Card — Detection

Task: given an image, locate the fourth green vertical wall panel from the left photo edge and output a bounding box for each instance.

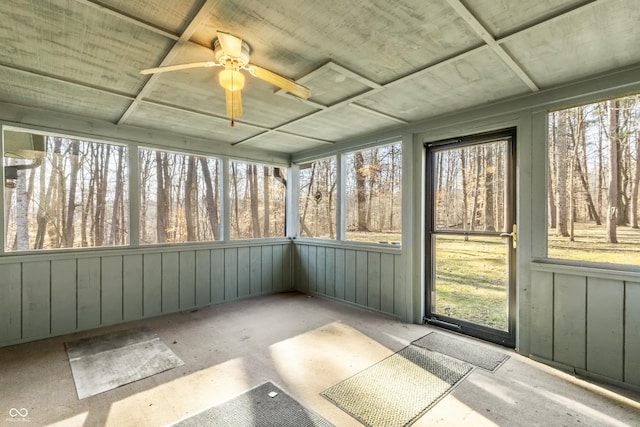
[78,258,102,330]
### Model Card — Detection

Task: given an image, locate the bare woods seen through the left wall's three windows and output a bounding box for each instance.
[4,130,286,252]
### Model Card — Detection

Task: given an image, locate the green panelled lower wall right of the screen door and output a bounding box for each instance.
[531,263,640,387]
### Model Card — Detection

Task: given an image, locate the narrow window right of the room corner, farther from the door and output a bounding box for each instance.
[299,157,337,239]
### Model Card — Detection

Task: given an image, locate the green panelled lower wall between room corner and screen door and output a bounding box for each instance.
[294,241,408,316]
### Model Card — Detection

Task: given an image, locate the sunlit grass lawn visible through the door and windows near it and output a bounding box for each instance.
[347,224,640,330]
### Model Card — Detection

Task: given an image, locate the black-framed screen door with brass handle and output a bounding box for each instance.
[425,130,517,347]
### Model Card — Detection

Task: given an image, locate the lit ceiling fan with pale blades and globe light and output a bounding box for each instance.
[140,31,311,126]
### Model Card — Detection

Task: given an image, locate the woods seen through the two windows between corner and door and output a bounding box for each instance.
[299,142,402,245]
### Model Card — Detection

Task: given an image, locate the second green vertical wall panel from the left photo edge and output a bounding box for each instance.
[22,261,51,339]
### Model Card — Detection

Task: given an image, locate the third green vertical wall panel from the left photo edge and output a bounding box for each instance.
[51,259,77,334]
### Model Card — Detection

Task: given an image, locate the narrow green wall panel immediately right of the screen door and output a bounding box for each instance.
[530,271,553,360]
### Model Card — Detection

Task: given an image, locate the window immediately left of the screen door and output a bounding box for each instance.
[345,143,402,244]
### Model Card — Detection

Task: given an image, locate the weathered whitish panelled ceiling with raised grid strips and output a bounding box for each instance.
[0,0,640,154]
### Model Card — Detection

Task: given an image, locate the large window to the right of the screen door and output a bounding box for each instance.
[547,95,640,265]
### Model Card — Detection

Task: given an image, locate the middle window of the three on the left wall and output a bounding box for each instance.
[139,149,220,244]
